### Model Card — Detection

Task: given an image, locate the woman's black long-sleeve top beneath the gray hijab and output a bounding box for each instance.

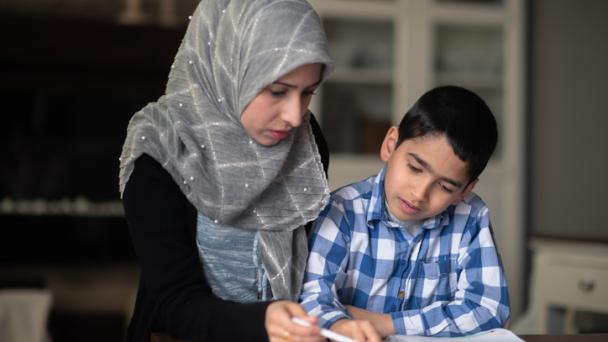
[123,116,329,342]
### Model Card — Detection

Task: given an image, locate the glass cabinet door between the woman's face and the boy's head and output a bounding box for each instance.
[320,18,393,154]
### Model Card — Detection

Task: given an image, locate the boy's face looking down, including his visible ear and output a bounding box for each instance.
[380,127,477,221]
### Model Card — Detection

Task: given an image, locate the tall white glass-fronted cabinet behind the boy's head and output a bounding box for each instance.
[311,0,525,317]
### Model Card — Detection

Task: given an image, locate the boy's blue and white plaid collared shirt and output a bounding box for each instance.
[300,169,509,336]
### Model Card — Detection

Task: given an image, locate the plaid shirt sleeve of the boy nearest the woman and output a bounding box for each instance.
[300,199,351,328]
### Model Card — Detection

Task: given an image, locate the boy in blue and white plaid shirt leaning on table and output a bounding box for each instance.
[300,86,509,338]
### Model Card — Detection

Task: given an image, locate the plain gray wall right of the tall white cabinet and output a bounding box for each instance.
[529,0,608,242]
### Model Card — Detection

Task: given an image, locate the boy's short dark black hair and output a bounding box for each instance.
[397,86,498,182]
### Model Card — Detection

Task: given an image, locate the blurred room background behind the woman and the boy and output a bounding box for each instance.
[0,0,608,342]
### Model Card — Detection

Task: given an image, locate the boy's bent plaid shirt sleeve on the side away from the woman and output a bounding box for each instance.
[391,207,509,336]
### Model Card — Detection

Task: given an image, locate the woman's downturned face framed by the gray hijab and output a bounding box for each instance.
[241,63,321,146]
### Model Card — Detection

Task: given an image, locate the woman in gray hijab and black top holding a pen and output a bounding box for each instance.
[120,0,331,341]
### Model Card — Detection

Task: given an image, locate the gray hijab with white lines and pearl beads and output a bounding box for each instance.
[120,0,332,299]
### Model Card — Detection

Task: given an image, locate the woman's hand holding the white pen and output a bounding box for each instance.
[265,300,325,342]
